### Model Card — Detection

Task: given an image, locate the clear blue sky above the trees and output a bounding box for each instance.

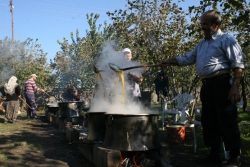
[0,0,196,62]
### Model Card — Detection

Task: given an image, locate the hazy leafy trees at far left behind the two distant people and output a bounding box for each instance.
[0,37,51,88]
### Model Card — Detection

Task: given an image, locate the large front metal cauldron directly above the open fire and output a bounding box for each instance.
[103,113,161,151]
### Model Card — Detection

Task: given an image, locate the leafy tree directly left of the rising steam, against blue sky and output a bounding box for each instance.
[51,13,115,90]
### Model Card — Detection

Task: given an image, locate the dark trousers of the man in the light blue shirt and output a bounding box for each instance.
[200,77,241,156]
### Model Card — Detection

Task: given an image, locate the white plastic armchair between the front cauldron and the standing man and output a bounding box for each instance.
[162,93,194,129]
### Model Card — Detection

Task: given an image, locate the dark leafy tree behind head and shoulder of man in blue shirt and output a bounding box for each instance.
[189,0,250,96]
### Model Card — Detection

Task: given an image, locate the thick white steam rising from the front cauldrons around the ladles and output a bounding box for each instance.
[89,41,151,114]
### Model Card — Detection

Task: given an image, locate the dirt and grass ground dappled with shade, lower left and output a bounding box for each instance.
[0,115,93,167]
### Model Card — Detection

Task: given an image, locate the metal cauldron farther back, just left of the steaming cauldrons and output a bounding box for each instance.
[58,101,82,118]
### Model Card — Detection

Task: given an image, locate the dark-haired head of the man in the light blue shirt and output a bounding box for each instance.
[200,10,221,38]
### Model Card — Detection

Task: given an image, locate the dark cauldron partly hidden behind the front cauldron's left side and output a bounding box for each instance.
[87,112,106,142]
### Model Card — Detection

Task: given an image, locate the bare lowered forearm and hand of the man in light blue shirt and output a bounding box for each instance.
[228,68,243,104]
